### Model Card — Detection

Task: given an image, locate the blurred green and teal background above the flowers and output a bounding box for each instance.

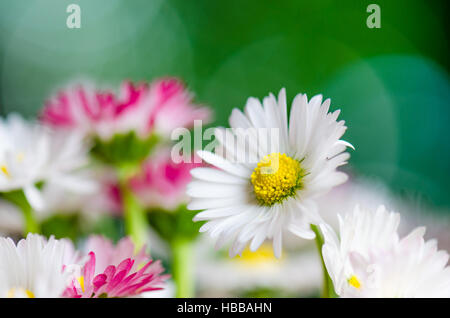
[0,0,450,211]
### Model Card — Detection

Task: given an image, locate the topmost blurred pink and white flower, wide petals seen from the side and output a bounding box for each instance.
[41,78,211,140]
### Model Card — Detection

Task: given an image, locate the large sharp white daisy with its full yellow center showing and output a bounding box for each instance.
[187,89,351,257]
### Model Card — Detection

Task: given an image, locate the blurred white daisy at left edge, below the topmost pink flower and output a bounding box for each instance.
[0,114,95,210]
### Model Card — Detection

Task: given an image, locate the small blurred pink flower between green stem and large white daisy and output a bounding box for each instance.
[130,151,202,210]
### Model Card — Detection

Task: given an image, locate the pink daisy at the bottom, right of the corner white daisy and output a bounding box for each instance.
[64,236,168,298]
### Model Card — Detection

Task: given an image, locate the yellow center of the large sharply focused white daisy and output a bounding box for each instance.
[251,152,304,206]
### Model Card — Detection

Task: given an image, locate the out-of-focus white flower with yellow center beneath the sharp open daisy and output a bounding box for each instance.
[196,236,323,297]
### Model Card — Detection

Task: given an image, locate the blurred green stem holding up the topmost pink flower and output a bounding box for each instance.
[118,166,148,250]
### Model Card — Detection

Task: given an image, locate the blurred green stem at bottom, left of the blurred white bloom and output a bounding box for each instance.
[171,239,194,298]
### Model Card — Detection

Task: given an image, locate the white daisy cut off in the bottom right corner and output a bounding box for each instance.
[320,206,450,298]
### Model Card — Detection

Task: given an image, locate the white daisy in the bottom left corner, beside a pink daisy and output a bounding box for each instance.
[0,234,73,298]
